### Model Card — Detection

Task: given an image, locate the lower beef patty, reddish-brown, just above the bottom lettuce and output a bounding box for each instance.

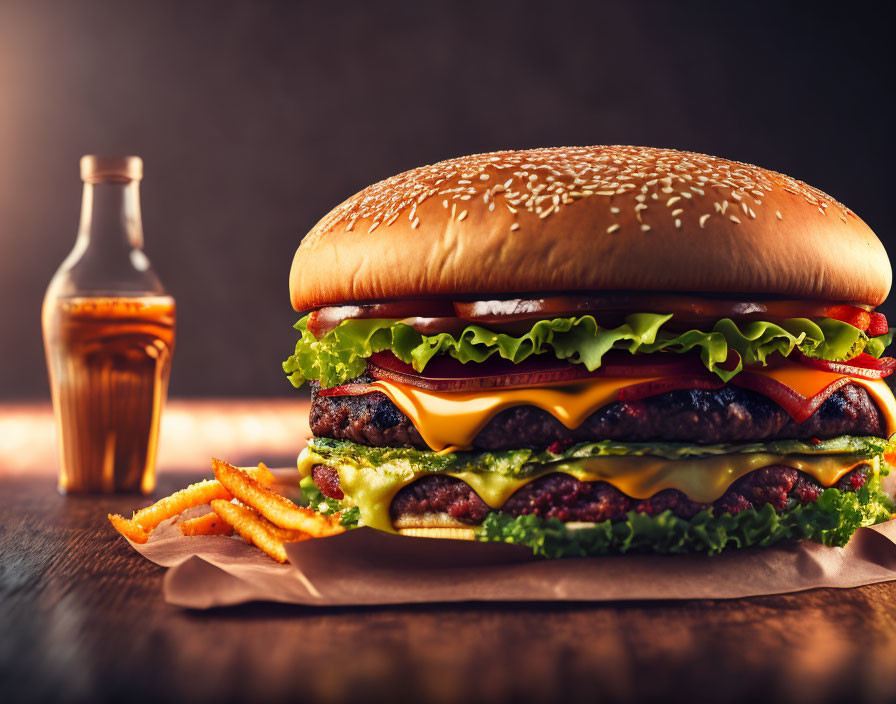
[312,465,869,525]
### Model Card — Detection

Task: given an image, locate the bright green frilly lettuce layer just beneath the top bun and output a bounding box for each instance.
[283,313,891,388]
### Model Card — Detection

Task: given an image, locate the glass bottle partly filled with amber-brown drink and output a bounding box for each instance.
[42,156,175,493]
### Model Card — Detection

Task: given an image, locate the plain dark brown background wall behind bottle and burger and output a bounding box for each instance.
[0,0,896,399]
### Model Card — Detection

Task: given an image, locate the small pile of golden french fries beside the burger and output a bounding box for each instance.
[109,459,345,562]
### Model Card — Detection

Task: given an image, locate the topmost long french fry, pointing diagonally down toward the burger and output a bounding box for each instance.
[212,459,345,538]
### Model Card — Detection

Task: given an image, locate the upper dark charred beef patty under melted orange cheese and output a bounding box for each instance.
[311,377,885,450]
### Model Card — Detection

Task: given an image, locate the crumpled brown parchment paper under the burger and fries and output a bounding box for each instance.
[124,471,896,609]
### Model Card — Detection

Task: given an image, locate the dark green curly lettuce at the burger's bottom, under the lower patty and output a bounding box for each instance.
[477,475,894,558]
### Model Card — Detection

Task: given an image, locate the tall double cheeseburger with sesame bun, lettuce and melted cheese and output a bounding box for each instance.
[283,146,896,557]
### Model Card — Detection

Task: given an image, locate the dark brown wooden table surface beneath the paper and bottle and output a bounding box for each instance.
[0,408,896,704]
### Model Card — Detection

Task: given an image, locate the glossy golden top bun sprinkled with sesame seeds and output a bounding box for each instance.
[289,146,892,310]
